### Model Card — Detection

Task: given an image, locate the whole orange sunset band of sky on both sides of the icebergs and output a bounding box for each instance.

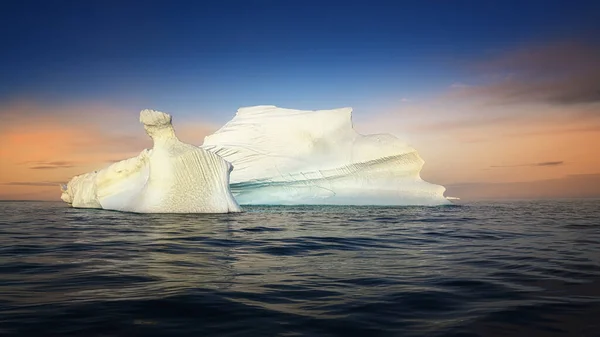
[0,98,600,200]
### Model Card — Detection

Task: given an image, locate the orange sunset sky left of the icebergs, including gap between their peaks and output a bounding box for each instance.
[0,103,216,200]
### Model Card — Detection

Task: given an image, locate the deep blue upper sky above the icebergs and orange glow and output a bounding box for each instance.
[0,1,600,122]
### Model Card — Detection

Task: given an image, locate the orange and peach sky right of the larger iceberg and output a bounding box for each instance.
[358,100,600,200]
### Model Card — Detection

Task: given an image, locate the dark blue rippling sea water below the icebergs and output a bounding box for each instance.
[0,200,600,336]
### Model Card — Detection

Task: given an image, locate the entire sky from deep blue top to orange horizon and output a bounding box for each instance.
[0,0,600,200]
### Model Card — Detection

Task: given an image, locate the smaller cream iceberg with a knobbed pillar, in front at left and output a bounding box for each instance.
[61,110,240,213]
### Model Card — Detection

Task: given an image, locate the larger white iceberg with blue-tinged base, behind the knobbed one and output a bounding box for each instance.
[202,106,449,205]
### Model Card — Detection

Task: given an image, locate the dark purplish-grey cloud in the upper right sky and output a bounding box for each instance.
[453,41,600,107]
